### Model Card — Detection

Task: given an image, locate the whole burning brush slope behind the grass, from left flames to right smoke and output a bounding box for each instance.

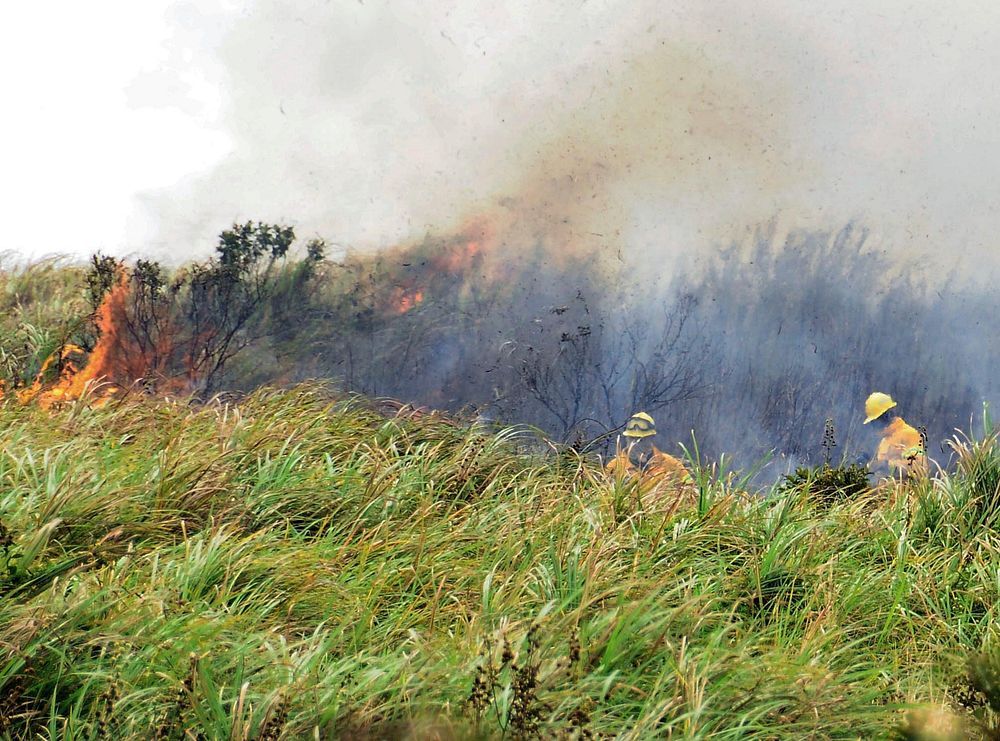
[6,215,1000,480]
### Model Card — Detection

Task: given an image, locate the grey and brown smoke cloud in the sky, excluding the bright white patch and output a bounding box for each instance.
[127,0,1000,278]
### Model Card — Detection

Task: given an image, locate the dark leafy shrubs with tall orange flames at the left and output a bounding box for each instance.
[6,223,323,406]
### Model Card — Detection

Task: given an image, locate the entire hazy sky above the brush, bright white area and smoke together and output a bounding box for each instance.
[0,0,1000,274]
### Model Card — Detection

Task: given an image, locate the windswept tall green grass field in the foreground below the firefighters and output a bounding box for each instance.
[0,385,1000,739]
